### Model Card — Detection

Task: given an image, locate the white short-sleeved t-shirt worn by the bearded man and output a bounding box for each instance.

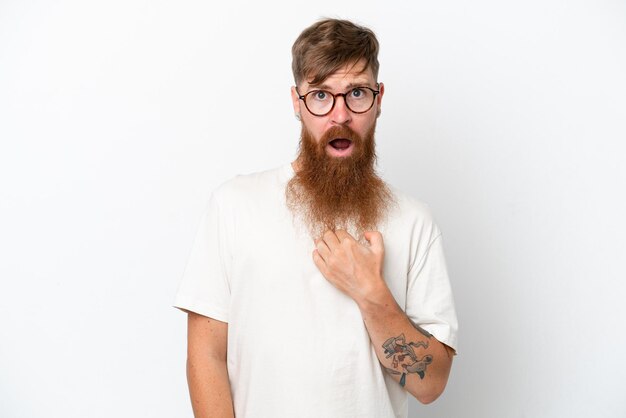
[174,164,457,418]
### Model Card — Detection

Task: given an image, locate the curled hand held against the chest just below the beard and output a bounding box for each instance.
[313,229,385,303]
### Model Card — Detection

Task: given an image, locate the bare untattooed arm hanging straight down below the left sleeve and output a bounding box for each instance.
[187,312,234,418]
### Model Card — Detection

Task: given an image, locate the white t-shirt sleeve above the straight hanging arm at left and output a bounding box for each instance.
[174,192,231,322]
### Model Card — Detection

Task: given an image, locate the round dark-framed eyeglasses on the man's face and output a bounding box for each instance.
[296,84,380,116]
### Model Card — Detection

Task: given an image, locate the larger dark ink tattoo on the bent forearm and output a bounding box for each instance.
[383,328,433,387]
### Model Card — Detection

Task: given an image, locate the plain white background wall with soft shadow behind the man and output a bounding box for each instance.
[0,0,626,418]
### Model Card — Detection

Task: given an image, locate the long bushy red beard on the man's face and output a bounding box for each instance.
[285,125,393,241]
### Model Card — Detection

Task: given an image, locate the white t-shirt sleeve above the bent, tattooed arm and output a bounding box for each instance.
[406,233,458,351]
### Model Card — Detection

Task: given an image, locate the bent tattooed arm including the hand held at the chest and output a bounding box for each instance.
[313,230,454,403]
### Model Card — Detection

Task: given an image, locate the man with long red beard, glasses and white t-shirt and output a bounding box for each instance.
[175,19,457,418]
